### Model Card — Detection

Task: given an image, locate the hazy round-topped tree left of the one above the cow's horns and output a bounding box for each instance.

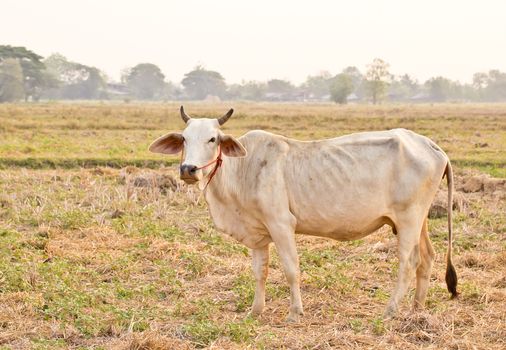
[122,63,165,100]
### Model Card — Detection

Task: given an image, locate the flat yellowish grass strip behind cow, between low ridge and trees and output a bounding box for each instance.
[0,103,506,177]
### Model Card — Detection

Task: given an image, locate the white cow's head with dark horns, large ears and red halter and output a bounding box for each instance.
[149,106,246,184]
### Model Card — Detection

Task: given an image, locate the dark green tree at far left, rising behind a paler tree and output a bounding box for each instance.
[0,45,51,100]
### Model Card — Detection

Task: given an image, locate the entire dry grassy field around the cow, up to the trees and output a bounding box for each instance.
[0,103,506,349]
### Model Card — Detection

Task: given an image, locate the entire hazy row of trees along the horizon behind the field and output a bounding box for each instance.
[0,45,506,104]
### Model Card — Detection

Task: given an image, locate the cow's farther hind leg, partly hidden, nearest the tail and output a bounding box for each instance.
[413,218,435,309]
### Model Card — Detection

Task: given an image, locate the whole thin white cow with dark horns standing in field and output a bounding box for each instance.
[149,106,458,322]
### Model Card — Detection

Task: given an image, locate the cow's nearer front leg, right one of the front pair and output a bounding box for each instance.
[269,224,304,322]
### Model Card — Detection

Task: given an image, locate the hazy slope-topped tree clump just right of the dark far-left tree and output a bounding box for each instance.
[44,54,107,99]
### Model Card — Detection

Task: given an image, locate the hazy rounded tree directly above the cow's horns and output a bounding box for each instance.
[181,66,227,100]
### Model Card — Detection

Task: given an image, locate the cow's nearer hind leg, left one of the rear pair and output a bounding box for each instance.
[384,215,423,318]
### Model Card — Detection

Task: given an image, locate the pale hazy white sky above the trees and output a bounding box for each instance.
[0,0,506,83]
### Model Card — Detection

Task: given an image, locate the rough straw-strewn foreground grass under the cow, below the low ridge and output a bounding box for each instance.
[0,168,506,349]
